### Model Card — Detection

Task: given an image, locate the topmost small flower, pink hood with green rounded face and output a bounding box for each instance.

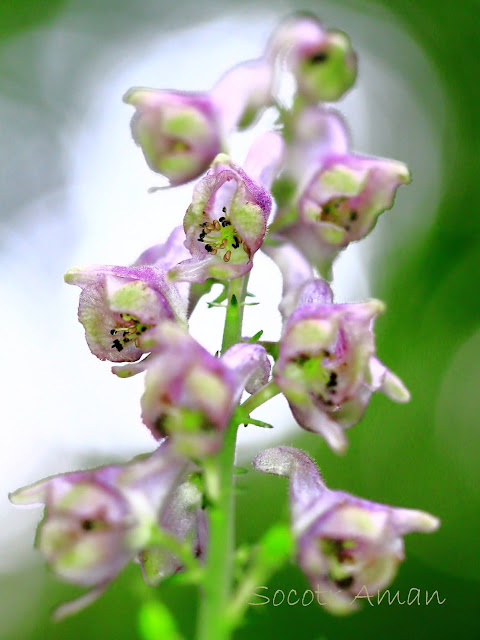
[267,15,357,102]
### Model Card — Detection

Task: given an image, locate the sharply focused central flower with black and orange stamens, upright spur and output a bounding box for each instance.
[170,132,283,283]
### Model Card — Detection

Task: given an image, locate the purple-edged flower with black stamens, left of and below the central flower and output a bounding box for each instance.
[65,227,188,362]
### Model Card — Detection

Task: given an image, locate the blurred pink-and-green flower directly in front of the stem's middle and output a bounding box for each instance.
[113,323,270,458]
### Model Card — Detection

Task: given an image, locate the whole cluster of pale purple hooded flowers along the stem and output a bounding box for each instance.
[11,15,438,637]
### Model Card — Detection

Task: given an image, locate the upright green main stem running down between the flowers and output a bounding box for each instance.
[197,276,248,640]
